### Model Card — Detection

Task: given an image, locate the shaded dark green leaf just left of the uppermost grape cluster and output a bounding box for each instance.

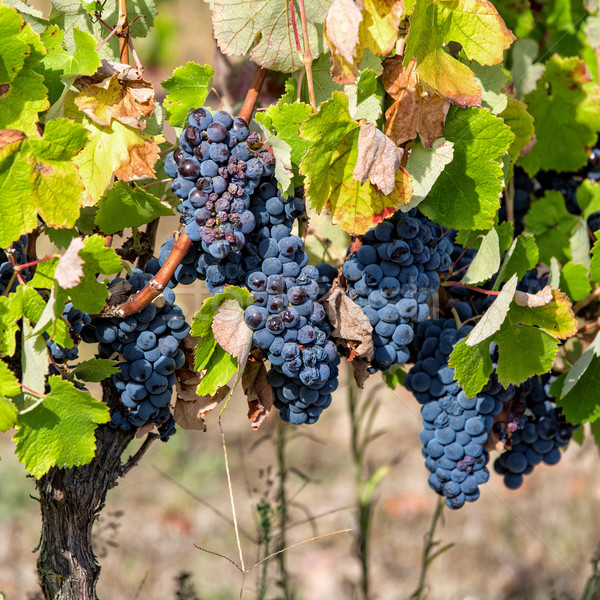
[96,181,173,235]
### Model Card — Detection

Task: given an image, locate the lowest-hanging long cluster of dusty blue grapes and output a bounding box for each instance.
[404,314,504,508]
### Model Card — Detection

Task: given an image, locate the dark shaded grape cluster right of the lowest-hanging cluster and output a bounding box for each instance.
[494,374,577,490]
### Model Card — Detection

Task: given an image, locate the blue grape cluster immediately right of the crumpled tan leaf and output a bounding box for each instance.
[342,209,453,371]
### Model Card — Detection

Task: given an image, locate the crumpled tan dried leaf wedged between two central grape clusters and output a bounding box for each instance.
[322,287,373,360]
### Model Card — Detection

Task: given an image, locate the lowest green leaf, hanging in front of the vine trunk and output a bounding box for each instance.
[13,375,110,479]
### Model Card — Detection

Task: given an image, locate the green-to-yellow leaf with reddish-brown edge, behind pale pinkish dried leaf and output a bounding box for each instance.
[300,92,412,235]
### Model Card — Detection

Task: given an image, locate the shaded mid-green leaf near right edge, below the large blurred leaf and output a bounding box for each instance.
[525,190,577,265]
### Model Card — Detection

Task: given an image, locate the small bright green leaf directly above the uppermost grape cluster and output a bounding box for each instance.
[161,61,215,127]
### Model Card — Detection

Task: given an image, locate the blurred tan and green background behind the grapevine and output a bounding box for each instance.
[0,0,600,600]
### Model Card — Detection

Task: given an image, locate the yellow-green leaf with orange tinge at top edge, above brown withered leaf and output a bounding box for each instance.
[404,0,515,106]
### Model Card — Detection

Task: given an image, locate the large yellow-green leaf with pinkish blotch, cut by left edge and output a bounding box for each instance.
[0,119,87,247]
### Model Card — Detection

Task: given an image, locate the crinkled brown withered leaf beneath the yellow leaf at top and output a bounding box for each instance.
[382,56,450,149]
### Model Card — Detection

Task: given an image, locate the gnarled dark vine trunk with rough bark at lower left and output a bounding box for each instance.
[36,385,134,600]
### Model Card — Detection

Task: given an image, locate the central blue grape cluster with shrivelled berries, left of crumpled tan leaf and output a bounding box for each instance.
[244,232,340,425]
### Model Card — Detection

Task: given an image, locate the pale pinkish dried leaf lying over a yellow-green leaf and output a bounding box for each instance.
[352,123,403,196]
